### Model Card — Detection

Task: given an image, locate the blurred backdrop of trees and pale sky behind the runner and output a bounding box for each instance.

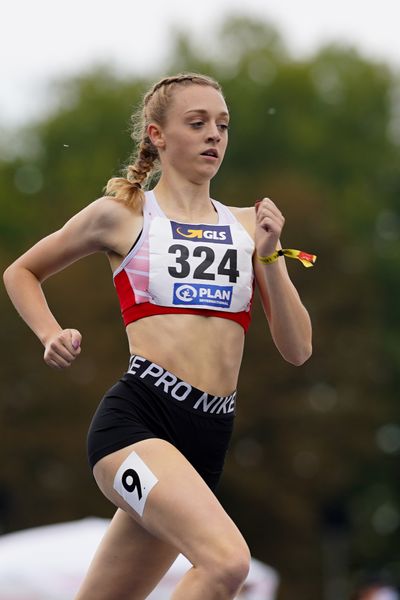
[0,0,400,600]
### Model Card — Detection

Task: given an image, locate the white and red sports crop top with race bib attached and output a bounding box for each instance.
[114,191,254,329]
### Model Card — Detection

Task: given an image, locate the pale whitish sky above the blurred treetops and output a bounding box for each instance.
[0,0,400,126]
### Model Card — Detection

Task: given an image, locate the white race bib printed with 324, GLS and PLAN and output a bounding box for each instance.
[149,217,254,312]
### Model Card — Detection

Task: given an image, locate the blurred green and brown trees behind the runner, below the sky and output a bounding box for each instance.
[0,16,400,600]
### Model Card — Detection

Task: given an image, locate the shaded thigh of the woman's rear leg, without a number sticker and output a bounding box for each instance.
[75,509,178,600]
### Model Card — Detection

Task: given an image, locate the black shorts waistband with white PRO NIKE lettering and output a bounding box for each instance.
[127,354,236,419]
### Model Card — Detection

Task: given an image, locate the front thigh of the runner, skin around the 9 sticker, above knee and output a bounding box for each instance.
[94,439,247,566]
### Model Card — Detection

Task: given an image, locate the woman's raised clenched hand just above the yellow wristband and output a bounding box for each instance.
[255,198,285,256]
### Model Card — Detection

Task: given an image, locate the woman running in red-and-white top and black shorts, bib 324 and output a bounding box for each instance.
[4,74,314,600]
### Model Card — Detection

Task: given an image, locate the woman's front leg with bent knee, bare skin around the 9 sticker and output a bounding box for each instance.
[93,439,250,600]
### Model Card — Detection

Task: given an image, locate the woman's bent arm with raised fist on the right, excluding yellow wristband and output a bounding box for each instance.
[254,198,312,366]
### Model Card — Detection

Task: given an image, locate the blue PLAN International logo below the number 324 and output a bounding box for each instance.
[172,283,233,309]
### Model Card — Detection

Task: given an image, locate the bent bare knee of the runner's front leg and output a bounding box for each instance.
[206,542,251,595]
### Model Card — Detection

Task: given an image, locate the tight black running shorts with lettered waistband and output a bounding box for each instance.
[88,355,236,490]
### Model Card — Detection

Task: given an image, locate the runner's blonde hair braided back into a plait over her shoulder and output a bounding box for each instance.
[105,73,222,208]
